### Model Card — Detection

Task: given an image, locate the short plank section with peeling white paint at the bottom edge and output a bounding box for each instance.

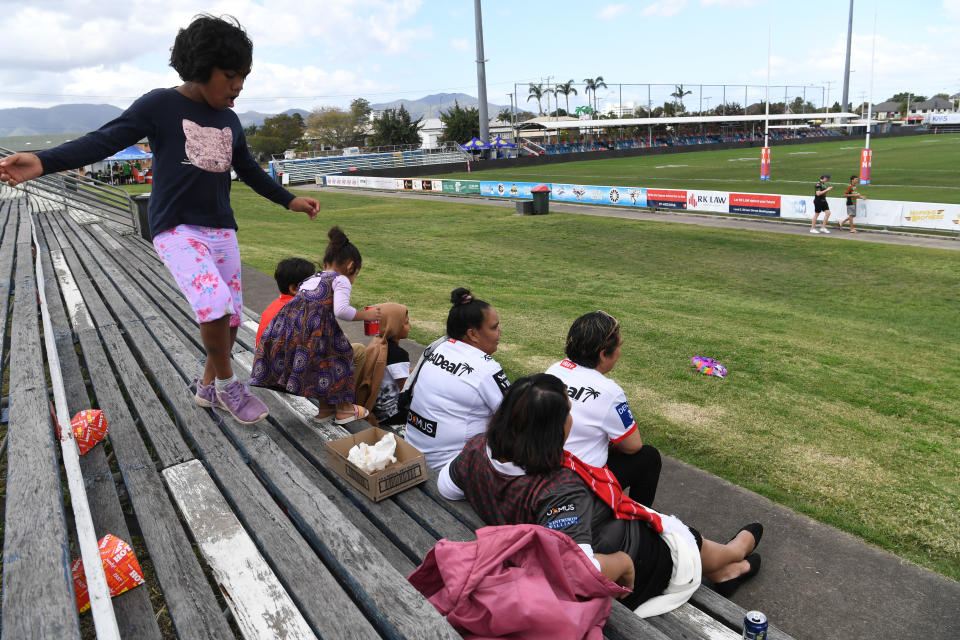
[163,460,316,640]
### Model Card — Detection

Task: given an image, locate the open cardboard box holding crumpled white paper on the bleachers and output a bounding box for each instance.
[327,427,427,502]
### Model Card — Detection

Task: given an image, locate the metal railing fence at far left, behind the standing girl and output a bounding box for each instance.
[0,147,140,233]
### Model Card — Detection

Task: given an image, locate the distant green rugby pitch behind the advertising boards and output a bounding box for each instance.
[437,134,960,203]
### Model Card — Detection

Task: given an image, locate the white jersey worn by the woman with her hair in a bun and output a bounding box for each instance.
[404,339,510,468]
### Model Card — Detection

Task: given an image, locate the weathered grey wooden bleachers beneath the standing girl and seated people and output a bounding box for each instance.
[0,186,787,639]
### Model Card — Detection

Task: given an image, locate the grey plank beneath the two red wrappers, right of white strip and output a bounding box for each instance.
[37,216,161,640]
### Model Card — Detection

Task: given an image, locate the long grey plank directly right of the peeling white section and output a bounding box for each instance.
[51,215,376,638]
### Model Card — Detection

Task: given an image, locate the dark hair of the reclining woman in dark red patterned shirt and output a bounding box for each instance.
[487,373,570,474]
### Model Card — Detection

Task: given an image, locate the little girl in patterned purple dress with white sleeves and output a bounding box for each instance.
[250,227,380,424]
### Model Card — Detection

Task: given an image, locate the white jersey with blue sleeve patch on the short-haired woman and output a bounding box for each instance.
[547,359,637,467]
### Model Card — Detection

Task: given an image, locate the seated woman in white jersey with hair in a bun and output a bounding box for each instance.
[405,288,510,468]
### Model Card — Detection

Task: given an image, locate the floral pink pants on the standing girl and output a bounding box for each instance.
[153,224,243,327]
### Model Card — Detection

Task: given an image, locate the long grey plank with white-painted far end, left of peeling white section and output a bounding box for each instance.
[41,212,233,639]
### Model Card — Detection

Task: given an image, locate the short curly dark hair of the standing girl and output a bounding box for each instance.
[170,13,253,83]
